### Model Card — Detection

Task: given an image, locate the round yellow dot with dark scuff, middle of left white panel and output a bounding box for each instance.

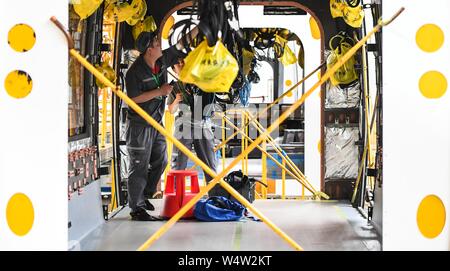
[5,70,33,99]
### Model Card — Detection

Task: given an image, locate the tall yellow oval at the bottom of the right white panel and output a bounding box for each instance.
[417,195,445,239]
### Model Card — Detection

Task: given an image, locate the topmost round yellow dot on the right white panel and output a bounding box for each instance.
[416,24,444,53]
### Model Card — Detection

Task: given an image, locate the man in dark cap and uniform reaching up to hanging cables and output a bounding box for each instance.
[125,28,198,221]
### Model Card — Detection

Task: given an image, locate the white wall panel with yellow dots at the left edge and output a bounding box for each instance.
[0,0,68,250]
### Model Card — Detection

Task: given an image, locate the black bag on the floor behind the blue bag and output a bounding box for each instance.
[222,170,267,203]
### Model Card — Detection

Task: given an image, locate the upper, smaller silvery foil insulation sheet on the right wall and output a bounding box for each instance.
[325,81,361,108]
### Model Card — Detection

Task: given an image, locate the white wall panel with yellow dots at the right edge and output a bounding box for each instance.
[383,0,450,250]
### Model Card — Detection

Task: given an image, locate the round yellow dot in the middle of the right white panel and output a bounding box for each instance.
[419,71,448,99]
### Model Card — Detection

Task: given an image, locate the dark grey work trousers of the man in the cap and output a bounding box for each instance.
[126,123,167,211]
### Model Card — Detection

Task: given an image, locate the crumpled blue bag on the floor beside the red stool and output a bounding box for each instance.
[194,197,246,222]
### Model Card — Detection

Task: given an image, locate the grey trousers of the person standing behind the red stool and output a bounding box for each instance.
[172,124,222,196]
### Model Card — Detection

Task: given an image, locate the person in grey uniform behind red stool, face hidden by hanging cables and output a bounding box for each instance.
[167,59,220,196]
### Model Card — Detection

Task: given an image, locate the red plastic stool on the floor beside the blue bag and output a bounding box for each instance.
[161,170,200,218]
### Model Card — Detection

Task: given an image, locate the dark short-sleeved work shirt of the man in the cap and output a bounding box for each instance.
[125,45,185,126]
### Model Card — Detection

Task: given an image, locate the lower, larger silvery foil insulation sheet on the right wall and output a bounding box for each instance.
[325,127,359,179]
